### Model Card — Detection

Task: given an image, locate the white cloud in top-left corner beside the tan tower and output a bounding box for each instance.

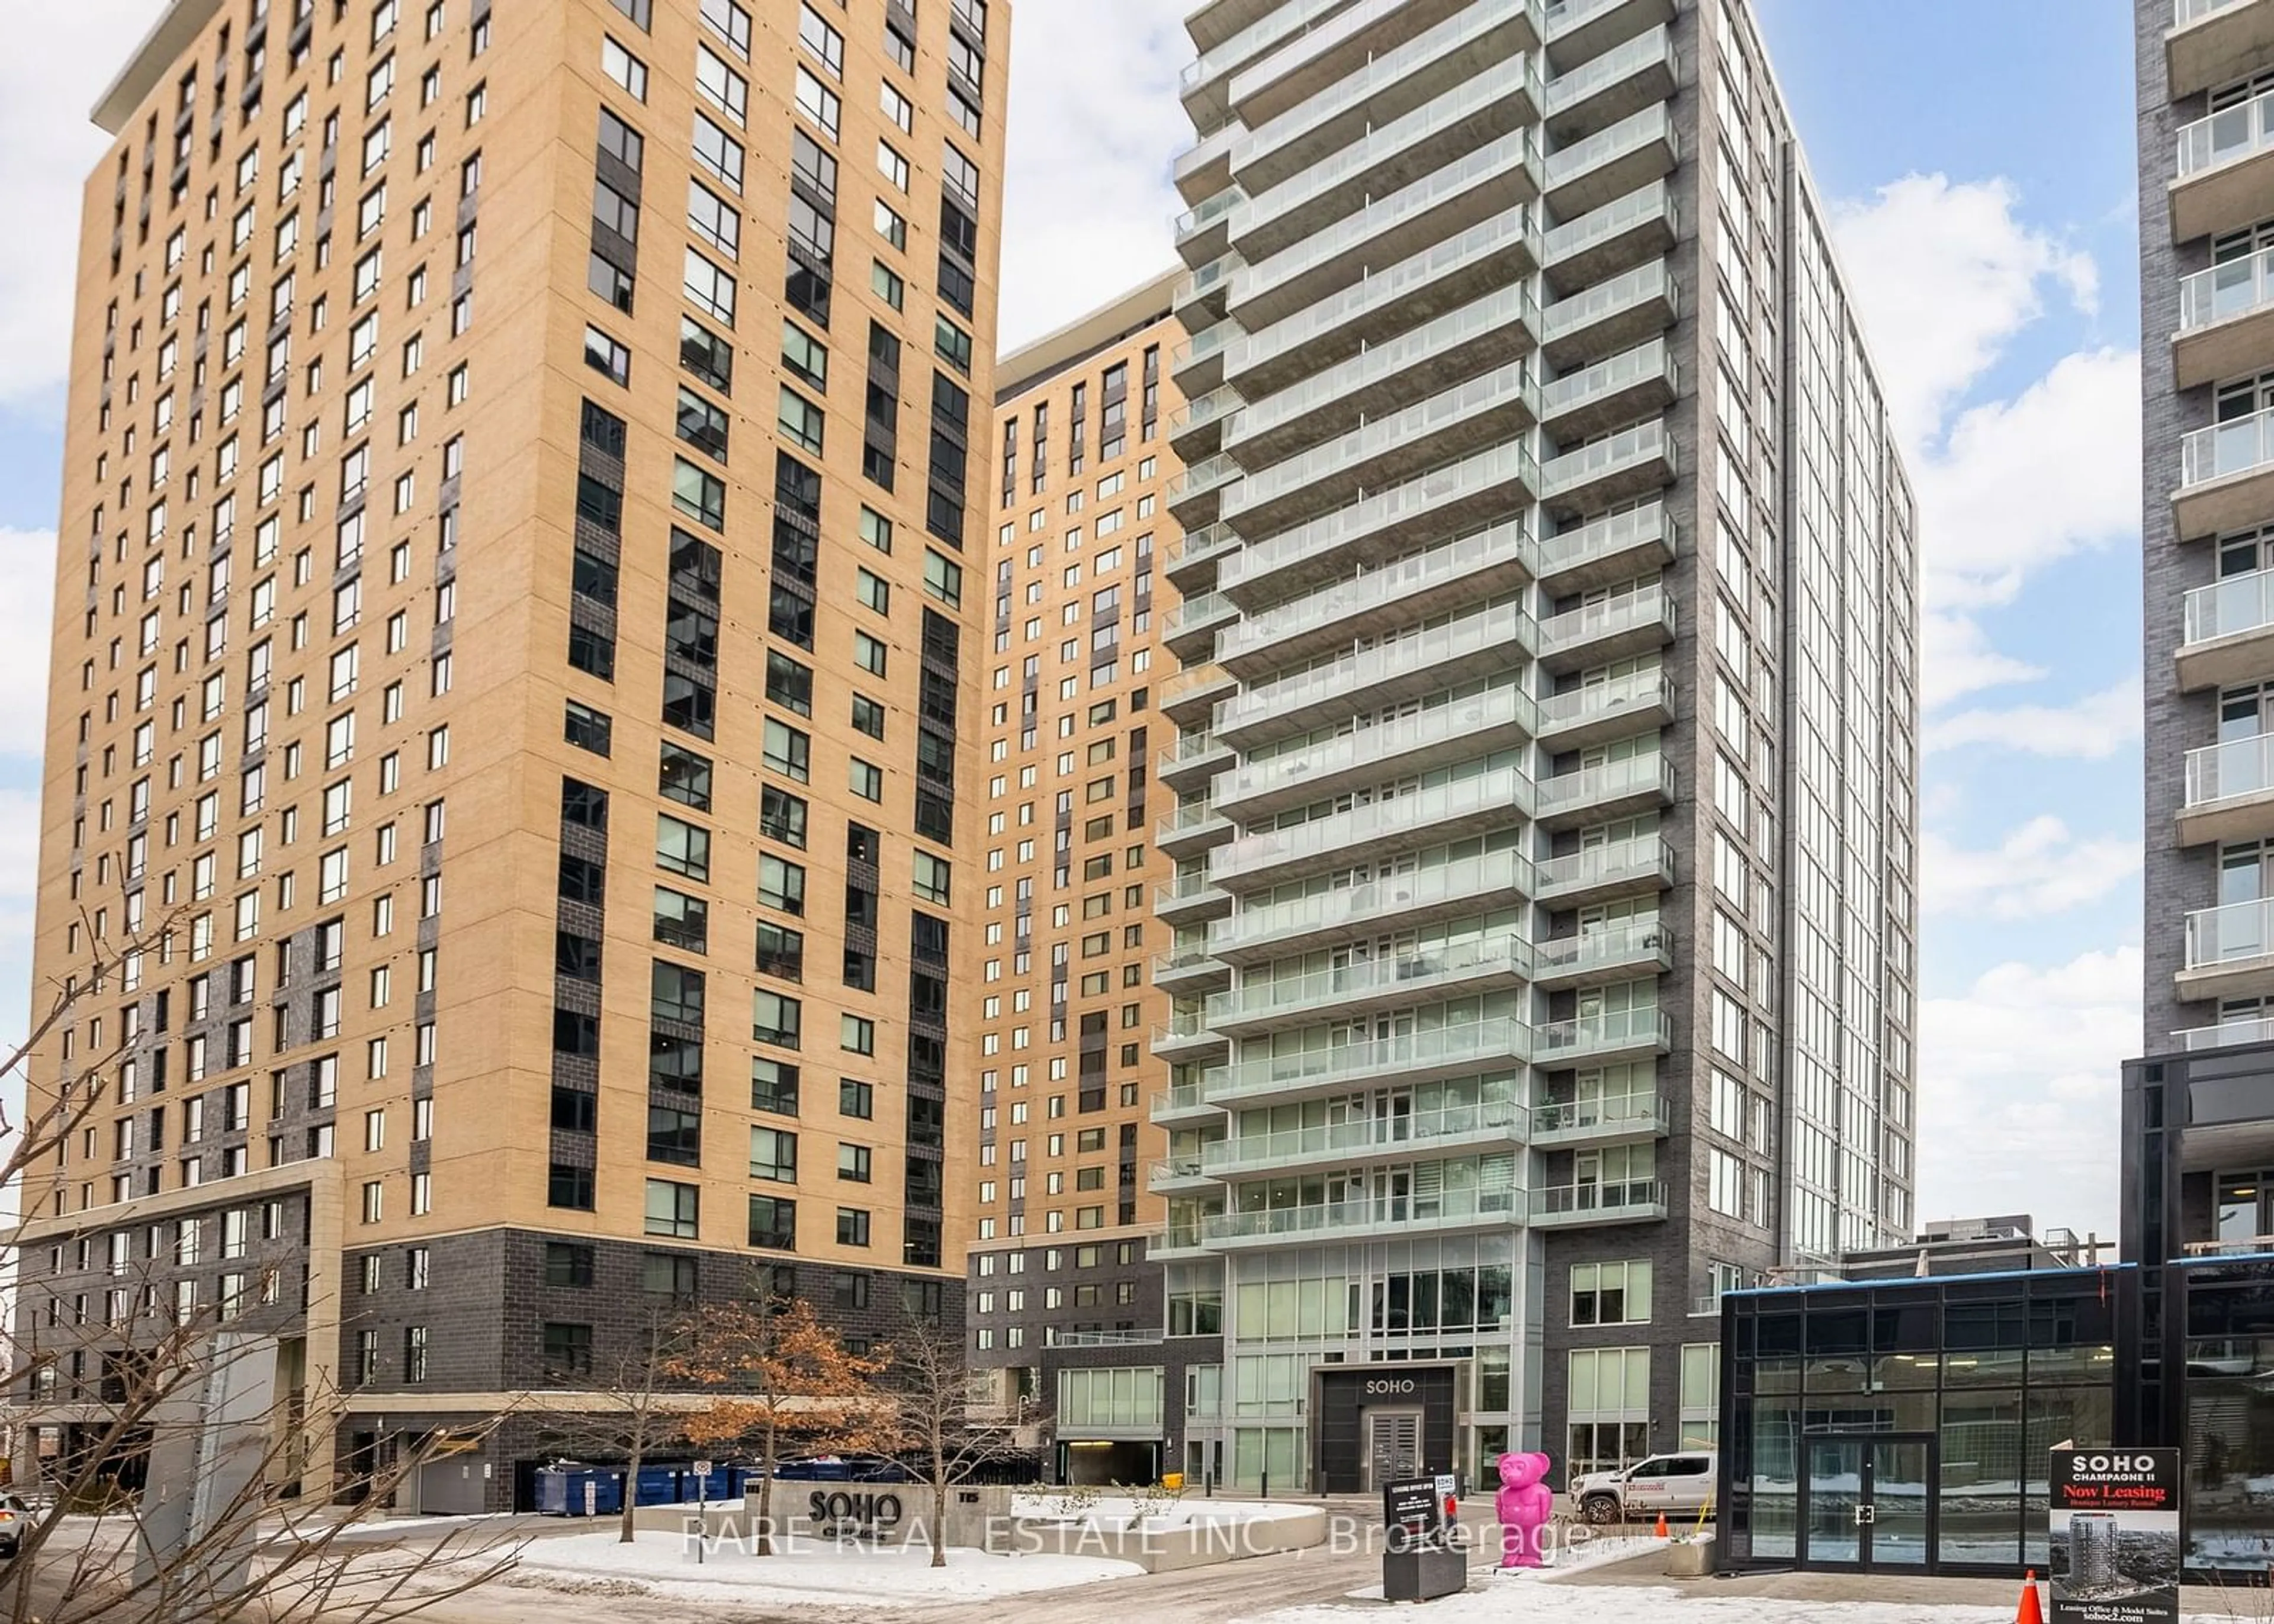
[0,0,162,405]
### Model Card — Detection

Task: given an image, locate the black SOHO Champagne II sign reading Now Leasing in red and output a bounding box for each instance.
[2049,1449,2183,1624]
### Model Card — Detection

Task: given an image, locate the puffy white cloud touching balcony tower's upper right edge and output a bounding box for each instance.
[1833,175,2099,446]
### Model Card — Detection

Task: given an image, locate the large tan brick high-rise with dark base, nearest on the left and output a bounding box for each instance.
[18,0,1010,1503]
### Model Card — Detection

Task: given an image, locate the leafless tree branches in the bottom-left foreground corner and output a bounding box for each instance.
[0,916,519,1624]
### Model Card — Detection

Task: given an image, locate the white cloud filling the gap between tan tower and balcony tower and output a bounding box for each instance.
[1001,0,1194,350]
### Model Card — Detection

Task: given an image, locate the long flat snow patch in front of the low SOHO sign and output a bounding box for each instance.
[497,1530,1144,1608]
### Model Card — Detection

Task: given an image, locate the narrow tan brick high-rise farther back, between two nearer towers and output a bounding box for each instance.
[964,271,1205,1481]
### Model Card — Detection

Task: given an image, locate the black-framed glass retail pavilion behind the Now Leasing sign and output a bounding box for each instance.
[1719,1265,2140,1574]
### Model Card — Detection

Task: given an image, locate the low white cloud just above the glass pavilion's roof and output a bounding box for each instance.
[1917,946,2140,1235]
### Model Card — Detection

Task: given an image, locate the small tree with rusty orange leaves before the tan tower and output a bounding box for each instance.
[673,1292,891,1556]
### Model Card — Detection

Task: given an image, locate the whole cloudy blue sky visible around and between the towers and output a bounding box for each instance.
[0,0,2140,1233]
